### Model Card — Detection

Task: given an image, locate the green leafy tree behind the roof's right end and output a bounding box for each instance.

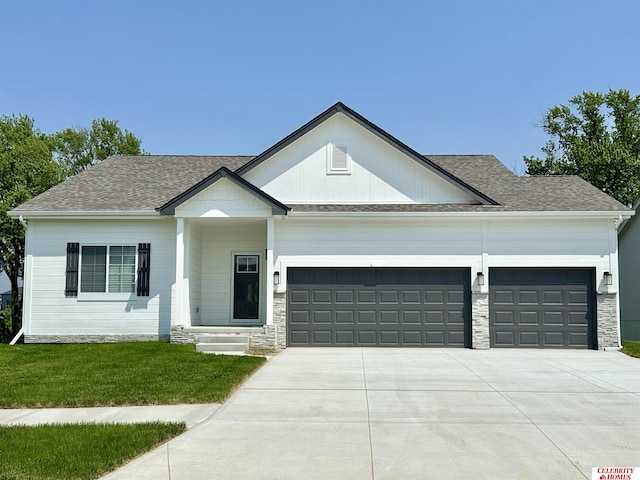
[524,89,640,205]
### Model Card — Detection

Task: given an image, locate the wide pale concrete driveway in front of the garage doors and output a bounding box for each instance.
[105,348,640,480]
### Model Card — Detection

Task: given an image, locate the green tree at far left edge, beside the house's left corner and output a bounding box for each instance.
[0,115,63,340]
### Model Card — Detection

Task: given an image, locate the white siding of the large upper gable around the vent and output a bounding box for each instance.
[244,114,473,204]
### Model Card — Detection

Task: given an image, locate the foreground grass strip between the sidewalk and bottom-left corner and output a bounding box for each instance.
[0,423,185,480]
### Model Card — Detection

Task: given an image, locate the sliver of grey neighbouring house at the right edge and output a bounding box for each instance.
[618,200,640,340]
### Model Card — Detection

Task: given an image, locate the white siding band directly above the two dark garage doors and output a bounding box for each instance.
[275,217,616,290]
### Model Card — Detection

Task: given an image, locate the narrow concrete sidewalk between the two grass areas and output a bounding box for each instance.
[0,403,220,428]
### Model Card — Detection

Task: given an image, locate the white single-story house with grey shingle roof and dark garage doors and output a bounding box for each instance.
[11,103,633,349]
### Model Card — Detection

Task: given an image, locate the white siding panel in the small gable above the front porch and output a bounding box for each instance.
[175,178,271,218]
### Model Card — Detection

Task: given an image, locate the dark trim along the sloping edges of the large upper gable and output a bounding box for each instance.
[236,102,497,205]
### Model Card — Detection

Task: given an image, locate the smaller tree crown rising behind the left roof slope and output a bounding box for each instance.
[52,118,145,176]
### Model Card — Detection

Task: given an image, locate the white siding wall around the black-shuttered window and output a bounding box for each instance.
[25,219,176,337]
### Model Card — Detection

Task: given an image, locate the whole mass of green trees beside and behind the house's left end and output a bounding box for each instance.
[0,115,143,342]
